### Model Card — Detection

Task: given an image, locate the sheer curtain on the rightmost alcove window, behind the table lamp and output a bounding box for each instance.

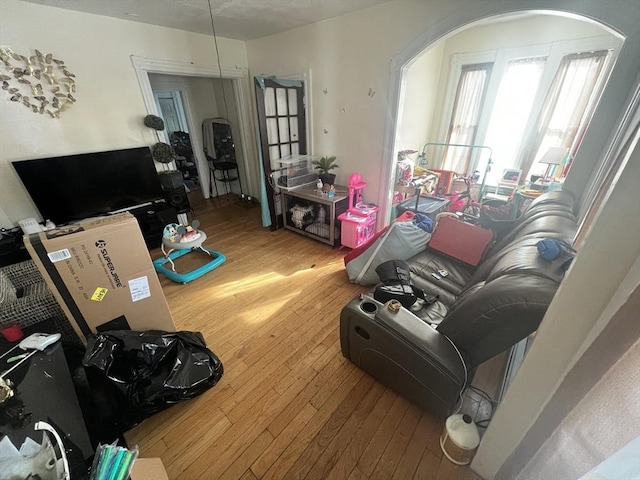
[521,50,609,181]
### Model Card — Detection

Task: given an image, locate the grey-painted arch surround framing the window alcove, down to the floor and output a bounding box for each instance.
[379,0,640,478]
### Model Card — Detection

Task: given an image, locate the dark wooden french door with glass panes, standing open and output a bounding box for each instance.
[254,77,307,230]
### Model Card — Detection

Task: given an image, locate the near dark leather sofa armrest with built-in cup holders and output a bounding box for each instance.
[340,295,467,417]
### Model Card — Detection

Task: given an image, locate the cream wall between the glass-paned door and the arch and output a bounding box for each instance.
[247,1,450,202]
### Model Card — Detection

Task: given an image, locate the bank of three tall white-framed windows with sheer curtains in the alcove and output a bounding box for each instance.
[440,37,618,185]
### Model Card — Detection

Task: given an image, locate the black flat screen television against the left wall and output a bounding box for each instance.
[13,147,163,225]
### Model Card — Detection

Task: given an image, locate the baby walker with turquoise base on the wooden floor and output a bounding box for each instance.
[153,230,227,283]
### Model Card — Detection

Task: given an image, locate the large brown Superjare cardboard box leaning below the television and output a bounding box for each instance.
[25,213,175,338]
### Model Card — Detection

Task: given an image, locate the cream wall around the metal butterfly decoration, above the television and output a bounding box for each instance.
[0,0,248,227]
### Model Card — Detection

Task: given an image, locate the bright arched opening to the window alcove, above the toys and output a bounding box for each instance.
[381,11,623,220]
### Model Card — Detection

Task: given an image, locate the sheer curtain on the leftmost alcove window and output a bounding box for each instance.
[442,63,493,173]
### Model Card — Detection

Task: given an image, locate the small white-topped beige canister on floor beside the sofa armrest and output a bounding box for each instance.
[440,414,480,465]
